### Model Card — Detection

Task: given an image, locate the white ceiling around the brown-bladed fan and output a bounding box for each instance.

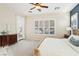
[0,3,77,15]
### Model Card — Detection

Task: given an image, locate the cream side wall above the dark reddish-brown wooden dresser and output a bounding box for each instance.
[0,4,16,34]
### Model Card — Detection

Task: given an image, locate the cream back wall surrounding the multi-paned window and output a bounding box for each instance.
[25,12,69,40]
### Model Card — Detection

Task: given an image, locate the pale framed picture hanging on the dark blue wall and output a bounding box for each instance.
[71,13,78,29]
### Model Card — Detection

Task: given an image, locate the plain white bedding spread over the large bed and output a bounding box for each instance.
[38,38,79,56]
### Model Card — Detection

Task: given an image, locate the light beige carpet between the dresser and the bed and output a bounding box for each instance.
[0,40,39,56]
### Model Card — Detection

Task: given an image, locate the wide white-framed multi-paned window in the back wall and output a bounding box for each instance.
[34,20,55,34]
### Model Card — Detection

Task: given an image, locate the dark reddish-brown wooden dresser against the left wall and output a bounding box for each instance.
[0,34,17,47]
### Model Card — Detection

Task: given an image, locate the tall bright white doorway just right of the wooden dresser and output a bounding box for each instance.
[17,16,25,40]
